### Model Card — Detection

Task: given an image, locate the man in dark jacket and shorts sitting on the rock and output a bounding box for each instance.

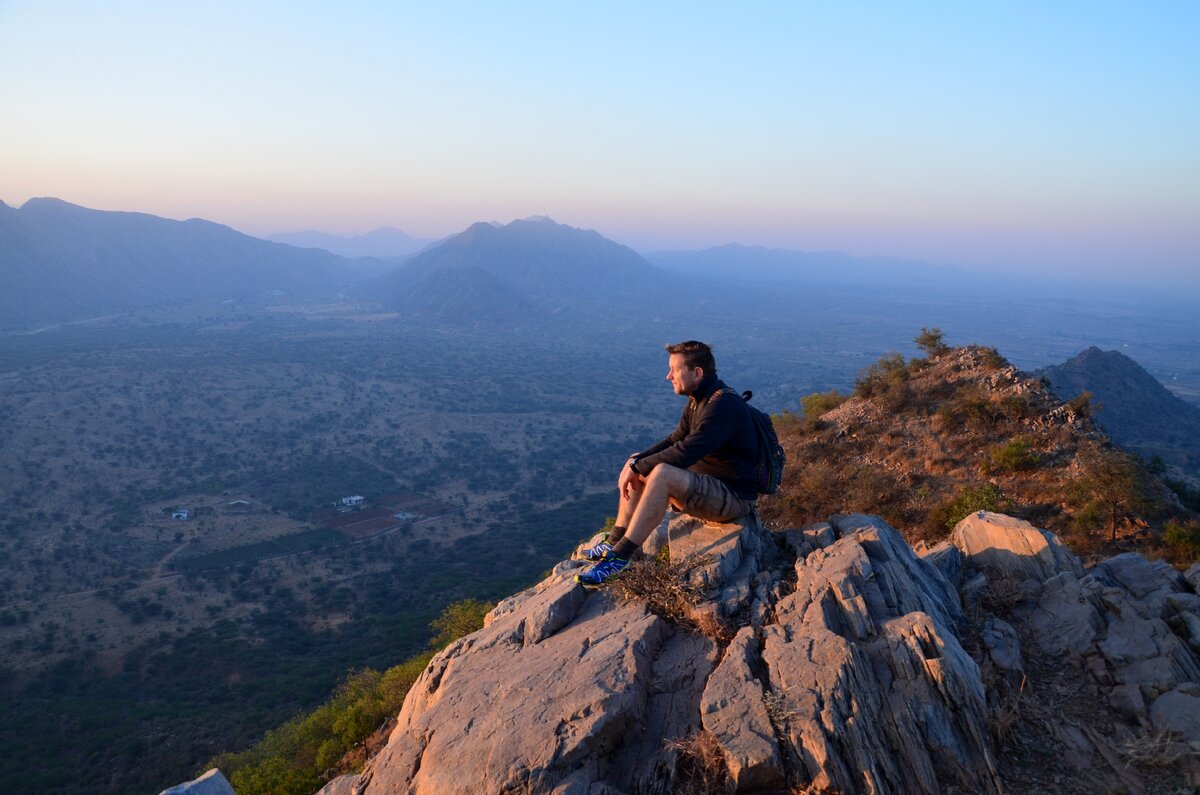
[575,340,758,587]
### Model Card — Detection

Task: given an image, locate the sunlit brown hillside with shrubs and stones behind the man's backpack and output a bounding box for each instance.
[763,346,1189,552]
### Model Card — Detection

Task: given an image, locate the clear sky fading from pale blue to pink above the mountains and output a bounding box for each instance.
[0,0,1200,285]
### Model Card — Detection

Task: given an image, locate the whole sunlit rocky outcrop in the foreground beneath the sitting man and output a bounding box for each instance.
[353,514,1200,795]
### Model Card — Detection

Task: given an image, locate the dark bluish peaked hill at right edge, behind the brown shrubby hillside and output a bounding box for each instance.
[1036,347,1200,476]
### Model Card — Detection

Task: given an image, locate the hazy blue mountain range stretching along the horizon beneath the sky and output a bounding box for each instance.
[0,198,1003,329]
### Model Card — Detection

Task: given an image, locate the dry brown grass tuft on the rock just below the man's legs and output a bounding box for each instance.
[608,555,733,645]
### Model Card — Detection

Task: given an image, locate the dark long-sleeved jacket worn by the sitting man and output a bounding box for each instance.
[634,373,758,500]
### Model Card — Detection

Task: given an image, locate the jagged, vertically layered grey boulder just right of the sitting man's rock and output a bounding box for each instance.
[763,516,1001,794]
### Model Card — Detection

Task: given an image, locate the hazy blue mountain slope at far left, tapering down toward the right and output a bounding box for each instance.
[0,198,353,328]
